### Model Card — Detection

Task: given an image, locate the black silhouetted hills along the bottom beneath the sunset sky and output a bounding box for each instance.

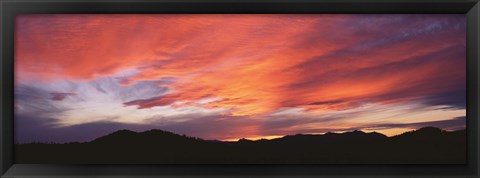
[15,127,466,164]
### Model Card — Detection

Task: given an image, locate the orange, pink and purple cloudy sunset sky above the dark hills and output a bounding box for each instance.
[15,14,466,143]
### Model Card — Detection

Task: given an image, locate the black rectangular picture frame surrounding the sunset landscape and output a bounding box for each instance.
[0,0,480,178]
